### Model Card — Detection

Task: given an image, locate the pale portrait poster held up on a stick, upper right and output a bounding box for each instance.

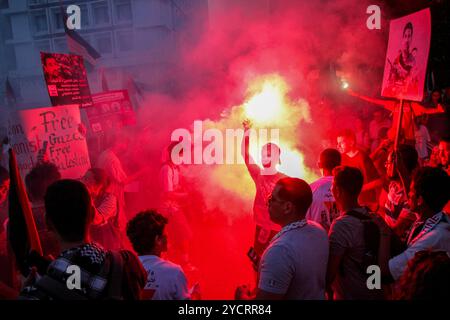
[381,9,431,101]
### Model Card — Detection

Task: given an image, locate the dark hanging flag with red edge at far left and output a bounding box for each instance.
[8,149,42,272]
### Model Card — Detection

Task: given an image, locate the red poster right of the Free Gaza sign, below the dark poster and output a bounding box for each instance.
[85,90,136,133]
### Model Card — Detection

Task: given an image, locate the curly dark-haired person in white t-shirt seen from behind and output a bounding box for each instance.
[127,210,190,300]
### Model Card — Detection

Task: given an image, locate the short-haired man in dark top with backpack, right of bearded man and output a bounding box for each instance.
[327,166,384,300]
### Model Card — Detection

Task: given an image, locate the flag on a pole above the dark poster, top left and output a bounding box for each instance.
[60,2,101,67]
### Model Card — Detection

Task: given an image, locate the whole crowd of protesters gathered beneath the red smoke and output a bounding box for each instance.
[0,86,450,300]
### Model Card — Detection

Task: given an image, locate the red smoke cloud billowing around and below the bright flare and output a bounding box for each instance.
[113,0,387,299]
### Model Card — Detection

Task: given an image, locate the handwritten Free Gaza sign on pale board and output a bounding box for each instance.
[7,105,90,179]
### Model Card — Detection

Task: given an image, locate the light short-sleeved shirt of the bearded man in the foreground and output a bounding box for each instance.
[258,221,328,300]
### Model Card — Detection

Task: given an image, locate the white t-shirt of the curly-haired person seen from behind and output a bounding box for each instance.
[139,255,190,300]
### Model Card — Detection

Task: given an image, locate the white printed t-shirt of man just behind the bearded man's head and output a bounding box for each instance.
[306,176,339,232]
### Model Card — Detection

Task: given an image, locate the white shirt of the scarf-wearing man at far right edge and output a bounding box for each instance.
[389,212,450,280]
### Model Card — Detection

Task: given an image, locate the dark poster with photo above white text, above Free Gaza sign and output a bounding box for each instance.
[41,52,92,108]
